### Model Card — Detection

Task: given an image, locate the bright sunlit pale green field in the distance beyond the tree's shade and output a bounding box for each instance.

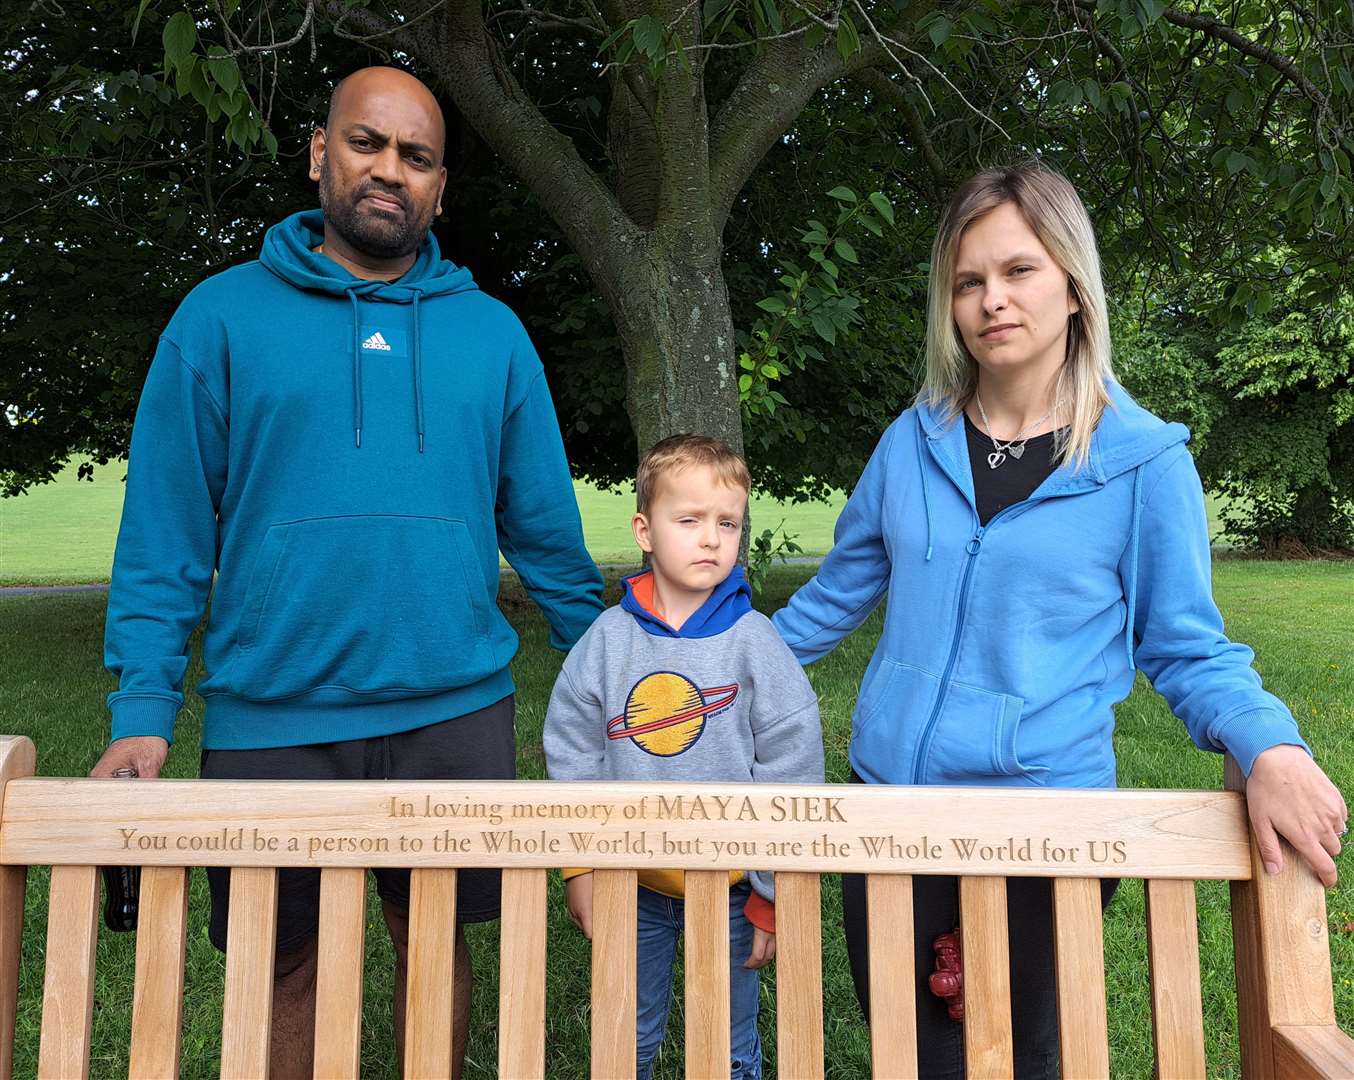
[0,462,1234,586]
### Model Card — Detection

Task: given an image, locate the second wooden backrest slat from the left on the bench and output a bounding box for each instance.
[127,866,188,1080]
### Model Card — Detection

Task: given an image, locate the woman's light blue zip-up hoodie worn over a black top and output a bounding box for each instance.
[773,383,1305,788]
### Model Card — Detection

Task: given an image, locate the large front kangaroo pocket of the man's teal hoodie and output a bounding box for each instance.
[219,516,496,701]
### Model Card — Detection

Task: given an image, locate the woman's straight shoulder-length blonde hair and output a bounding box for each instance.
[918,164,1114,468]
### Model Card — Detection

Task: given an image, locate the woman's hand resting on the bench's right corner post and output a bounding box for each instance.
[1246,744,1349,888]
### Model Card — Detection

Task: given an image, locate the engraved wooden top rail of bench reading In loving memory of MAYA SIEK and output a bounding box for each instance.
[0,780,1251,880]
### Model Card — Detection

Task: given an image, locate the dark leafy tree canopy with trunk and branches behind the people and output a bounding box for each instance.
[0,0,1354,549]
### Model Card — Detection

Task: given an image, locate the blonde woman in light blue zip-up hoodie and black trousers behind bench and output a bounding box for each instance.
[774,166,1346,1077]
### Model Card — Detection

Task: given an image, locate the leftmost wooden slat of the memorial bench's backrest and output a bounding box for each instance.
[38,866,99,1080]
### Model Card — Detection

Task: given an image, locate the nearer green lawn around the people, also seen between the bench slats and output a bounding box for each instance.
[0,560,1354,1080]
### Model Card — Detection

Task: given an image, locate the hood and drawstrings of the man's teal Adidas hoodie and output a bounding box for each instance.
[259,210,477,453]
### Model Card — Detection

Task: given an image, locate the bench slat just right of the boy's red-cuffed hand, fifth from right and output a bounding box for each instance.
[776,872,823,1080]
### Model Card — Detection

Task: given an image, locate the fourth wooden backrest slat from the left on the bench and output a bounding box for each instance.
[314,866,367,1080]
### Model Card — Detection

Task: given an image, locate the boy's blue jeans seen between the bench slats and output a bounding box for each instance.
[635,882,761,1080]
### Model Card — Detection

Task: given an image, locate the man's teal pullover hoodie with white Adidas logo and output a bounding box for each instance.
[106,211,603,748]
